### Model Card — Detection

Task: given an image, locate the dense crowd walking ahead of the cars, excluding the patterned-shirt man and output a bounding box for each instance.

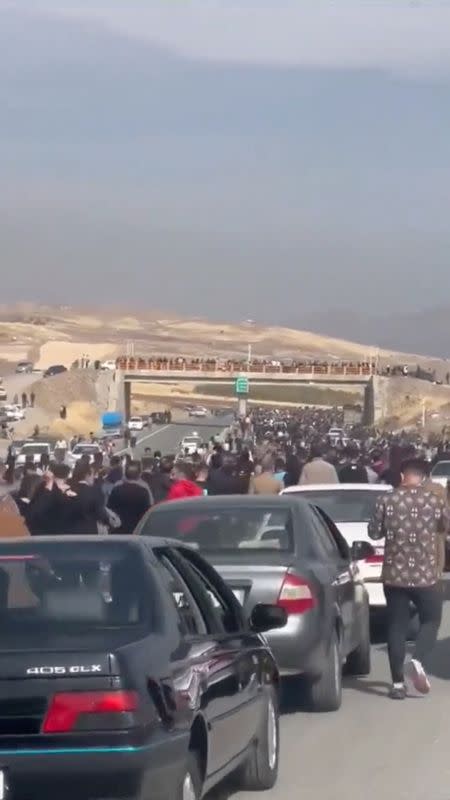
[1,408,447,535]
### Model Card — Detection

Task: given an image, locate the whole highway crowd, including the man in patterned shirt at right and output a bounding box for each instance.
[0,408,450,699]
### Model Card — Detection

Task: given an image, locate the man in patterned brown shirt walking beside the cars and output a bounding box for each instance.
[369,459,448,700]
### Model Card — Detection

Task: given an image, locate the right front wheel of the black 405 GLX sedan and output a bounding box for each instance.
[235,687,280,792]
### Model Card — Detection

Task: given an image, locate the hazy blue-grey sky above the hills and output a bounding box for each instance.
[0,0,450,348]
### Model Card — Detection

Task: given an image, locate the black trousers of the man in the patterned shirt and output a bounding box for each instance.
[384,583,443,683]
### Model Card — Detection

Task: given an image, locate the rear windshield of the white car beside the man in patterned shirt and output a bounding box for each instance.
[299,489,385,522]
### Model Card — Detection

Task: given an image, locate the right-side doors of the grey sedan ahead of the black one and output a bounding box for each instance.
[311,506,356,655]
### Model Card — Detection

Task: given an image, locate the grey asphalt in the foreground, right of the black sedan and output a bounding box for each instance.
[208,592,450,800]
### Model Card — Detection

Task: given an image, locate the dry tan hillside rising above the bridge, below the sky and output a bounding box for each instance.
[0,306,448,371]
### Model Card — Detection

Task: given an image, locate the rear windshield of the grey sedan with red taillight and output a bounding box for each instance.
[141,506,293,552]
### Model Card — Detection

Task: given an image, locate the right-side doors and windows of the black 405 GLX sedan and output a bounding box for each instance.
[164,546,267,766]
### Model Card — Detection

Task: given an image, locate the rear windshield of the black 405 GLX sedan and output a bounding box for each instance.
[0,540,152,647]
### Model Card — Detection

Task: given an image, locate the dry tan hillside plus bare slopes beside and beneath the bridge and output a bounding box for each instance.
[0,306,450,435]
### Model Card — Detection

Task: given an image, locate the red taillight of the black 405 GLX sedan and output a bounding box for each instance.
[42,691,139,733]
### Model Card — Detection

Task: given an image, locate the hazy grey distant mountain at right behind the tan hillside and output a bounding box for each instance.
[286,307,450,359]
